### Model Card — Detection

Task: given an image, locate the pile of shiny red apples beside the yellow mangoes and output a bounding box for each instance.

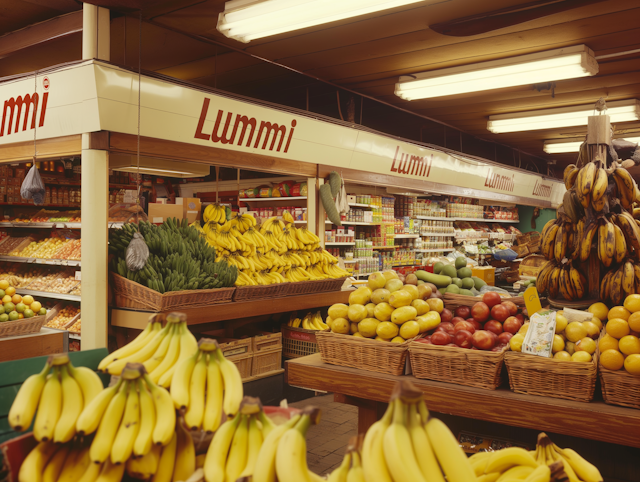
[416,291,526,351]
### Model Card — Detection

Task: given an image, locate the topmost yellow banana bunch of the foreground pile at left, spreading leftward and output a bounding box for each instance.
[98,313,198,388]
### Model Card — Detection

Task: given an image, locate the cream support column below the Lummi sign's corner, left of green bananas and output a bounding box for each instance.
[81,134,109,350]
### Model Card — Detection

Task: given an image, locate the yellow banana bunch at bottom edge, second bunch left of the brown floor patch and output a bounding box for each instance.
[203,397,282,482]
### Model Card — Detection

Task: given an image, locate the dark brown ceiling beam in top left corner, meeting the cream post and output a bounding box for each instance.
[0,10,82,59]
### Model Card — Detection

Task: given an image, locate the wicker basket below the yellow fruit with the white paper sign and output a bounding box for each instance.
[504,350,598,402]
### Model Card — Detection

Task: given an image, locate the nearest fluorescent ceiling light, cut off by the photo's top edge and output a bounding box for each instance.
[217,0,427,43]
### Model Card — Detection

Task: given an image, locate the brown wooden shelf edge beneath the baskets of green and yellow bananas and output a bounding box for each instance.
[111,290,352,330]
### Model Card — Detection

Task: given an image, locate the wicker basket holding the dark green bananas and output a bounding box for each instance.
[111,273,235,311]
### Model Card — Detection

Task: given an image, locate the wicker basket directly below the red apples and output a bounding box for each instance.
[409,342,507,390]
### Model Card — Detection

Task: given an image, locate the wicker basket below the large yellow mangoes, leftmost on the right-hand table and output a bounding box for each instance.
[316,331,410,375]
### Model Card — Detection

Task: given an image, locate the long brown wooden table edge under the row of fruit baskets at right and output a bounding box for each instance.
[285,353,640,447]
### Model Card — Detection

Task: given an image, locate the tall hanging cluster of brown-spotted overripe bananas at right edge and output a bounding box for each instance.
[536,130,640,304]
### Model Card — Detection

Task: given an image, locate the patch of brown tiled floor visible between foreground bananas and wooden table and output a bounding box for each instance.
[290,395,358,475]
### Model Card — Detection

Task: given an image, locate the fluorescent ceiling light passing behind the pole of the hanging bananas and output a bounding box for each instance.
[487,99,640,134]
